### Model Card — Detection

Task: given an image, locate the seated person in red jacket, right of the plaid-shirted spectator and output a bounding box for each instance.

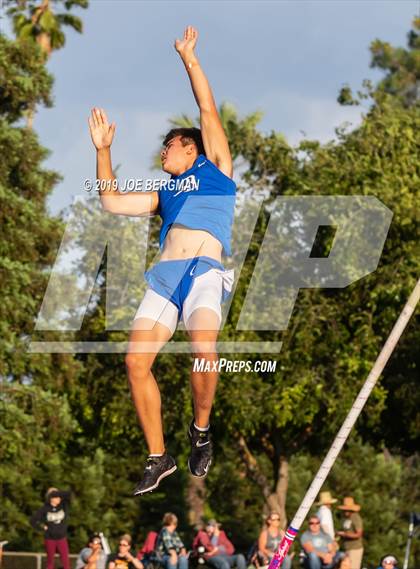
[193,520,246,569]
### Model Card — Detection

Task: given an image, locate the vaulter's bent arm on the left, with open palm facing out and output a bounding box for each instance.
[89,107,159,216]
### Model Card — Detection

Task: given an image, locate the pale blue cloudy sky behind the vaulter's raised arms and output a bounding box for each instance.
[3,0,419,213]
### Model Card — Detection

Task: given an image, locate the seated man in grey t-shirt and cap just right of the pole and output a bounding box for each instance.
[300,516,340,569]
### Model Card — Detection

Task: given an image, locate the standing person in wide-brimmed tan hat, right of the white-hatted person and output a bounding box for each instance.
[337,496,363,569]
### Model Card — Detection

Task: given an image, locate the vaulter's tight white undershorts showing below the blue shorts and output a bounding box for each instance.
[134,268,233,334]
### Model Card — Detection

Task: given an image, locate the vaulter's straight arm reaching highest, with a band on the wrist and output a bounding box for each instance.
[175,26,233,177]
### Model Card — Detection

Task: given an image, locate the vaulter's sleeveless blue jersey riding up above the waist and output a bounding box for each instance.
[159,154,236,255]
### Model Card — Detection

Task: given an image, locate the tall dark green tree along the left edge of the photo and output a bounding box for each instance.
[0,27,79,546]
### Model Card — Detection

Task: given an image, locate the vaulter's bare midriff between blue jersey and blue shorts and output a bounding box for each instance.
[160,223,222,262]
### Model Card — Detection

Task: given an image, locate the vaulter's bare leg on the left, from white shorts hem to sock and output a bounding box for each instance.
[126,318,173,454]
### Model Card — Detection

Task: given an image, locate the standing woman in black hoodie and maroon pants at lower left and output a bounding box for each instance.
[31,488,70,569]
